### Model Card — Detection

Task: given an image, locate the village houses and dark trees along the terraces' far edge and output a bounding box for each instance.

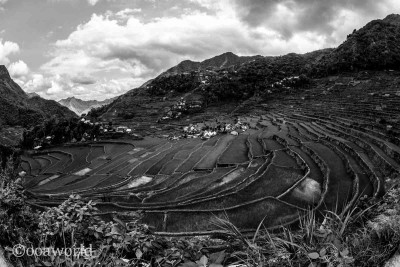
[33,92,253,150]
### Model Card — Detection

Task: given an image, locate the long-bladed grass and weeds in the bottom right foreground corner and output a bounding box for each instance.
[208,184,400,267]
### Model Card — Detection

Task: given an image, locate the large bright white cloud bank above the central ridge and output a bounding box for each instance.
[32,5,336,99]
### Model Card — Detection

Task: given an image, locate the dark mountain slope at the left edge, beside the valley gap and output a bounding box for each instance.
[0,65,76,127]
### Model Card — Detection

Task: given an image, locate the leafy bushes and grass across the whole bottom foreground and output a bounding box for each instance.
[0,160,400,267]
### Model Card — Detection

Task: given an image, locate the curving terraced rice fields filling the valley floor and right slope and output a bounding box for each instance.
[22,82,400,233]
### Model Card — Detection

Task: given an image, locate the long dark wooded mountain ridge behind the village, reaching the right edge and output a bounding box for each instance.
[98,15,400,122]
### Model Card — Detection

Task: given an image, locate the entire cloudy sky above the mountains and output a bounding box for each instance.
[0,0,400,100]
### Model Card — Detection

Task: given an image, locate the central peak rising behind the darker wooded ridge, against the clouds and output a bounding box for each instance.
[160,52,262,76]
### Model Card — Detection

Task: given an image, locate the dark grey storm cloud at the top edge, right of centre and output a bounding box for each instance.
[235,0,385,38]
